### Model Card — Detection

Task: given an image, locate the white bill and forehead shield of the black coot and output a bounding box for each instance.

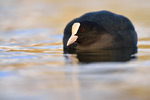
[67,23,80,46]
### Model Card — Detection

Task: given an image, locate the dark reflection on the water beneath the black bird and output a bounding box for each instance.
[64,48,137,63]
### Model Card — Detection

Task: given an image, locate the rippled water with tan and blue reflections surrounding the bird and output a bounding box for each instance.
[0,0,150,100]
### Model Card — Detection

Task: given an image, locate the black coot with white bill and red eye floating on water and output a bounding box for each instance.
[63,11,137,52]
